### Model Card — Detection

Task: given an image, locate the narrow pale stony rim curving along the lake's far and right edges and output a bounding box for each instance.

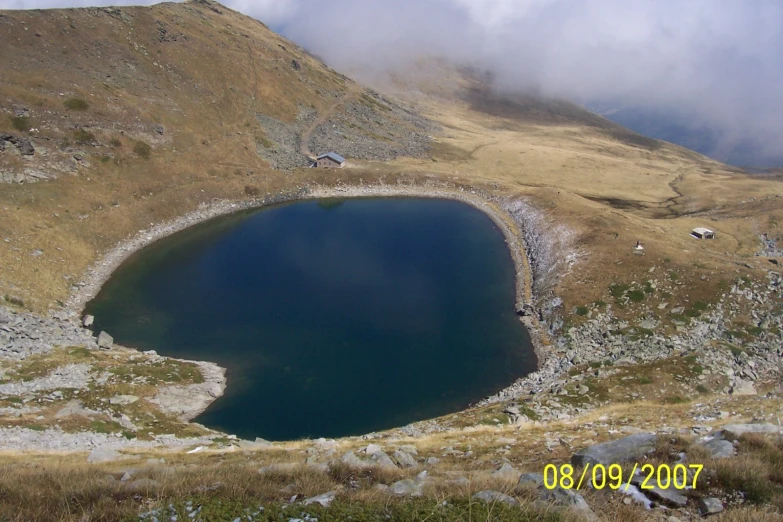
[66,185,550,422]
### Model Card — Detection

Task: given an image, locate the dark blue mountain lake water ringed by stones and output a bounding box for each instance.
[87,198,536,440]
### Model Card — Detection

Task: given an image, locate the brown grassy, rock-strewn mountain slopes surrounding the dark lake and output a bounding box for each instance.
[0,0,783,521]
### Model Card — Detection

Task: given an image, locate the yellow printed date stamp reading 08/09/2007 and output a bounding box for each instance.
[544,463,704,490]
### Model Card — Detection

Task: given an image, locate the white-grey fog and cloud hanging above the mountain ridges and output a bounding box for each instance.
[6,0,783,165]
